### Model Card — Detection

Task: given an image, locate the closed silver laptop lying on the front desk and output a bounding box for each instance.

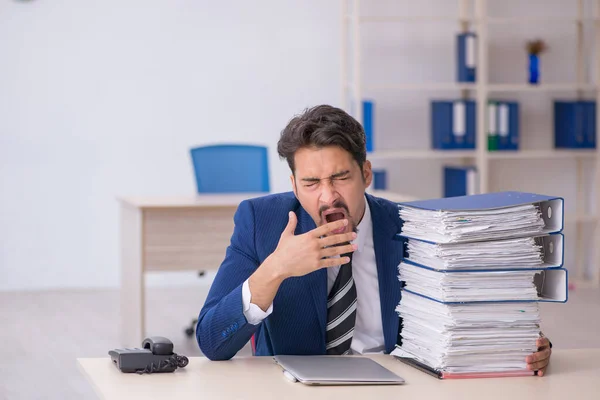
[273,355,404,385]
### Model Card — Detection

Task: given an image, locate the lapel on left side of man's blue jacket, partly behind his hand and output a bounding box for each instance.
[295,207,327,351]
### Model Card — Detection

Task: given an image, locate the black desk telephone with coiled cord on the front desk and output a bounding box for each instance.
[108,336,189,374]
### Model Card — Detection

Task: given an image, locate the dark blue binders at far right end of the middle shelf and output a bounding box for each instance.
[554,100,596,149]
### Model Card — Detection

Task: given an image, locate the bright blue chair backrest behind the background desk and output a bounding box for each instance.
[190,144,270,193]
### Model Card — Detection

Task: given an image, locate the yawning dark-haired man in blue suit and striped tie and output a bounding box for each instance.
[196,105,550,373]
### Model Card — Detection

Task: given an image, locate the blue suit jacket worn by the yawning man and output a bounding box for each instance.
[196,192,402,360]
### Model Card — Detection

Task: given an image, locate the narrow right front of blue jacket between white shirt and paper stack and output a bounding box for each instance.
[367,194,402,352]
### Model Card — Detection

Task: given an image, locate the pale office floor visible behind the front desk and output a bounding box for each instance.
[0,286,600,400]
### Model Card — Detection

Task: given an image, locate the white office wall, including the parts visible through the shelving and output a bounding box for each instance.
[0,0,592,290]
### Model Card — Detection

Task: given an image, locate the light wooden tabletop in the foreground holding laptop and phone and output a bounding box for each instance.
[78,349,600,400]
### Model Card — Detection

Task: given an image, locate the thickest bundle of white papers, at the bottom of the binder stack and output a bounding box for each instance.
[398,292,540,373]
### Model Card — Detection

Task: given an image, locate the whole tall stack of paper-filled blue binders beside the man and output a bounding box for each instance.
[392,192,567,377]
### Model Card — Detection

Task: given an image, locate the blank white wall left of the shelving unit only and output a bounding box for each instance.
[0,0,340,289]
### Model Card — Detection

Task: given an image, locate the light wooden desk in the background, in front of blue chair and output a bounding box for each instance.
[120,191,413,347]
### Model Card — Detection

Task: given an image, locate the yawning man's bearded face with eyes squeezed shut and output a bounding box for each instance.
[291,146,372,234]
